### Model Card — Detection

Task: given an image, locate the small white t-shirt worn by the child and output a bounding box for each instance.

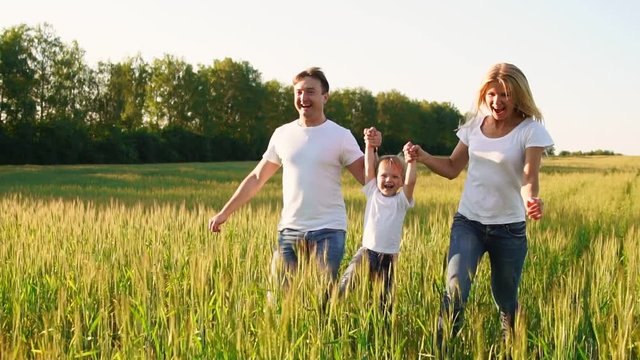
[362,178,415,254]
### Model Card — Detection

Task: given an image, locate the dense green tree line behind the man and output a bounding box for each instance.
[0,24,462,164]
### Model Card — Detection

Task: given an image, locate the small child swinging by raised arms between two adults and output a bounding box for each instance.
[339,128,416,310]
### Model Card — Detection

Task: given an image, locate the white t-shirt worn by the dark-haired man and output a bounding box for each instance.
[262,119,364,231]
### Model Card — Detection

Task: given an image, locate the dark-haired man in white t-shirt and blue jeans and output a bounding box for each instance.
[209,67,382,286]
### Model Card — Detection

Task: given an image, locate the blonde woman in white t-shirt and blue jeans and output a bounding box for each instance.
[404,63,553,337]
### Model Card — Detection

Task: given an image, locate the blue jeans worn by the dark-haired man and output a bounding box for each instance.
[274,229,346,285]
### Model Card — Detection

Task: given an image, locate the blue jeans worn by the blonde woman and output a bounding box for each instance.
[440,213,527,335]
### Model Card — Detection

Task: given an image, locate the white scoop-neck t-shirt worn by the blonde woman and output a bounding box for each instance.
[457,117,553,224]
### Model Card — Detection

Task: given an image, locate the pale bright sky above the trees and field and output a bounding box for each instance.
[0,0,640,155]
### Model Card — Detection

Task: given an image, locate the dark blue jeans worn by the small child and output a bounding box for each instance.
[339,246,398,312]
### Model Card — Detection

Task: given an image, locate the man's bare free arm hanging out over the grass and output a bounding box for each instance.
[209,159,280,232]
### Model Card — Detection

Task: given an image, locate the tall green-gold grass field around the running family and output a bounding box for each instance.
[0,157,640,359]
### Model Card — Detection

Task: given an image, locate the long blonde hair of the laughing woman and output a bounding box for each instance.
[467,63,542,126]
